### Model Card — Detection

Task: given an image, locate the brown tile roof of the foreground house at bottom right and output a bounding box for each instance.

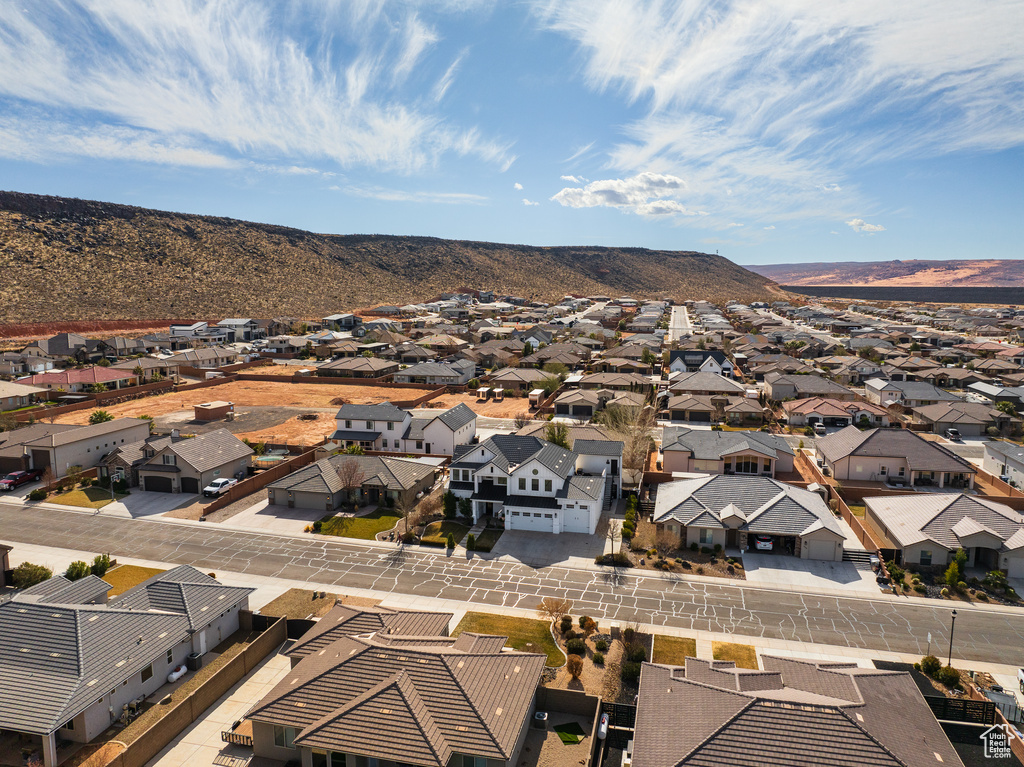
[633,655,964,767]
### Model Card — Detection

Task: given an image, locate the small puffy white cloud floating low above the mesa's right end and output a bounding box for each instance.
[551,172,707,217]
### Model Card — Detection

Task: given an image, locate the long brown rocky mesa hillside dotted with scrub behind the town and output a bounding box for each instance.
[0,191,769,323]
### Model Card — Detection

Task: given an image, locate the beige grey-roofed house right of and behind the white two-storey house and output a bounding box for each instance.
[660,426,796,477]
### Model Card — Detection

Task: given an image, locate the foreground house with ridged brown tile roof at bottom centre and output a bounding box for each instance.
[247,634,545,767]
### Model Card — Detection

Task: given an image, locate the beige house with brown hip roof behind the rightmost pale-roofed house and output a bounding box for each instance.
[817,426,977,487]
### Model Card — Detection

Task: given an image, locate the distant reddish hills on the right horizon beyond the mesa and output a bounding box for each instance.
[745,259,1024,288]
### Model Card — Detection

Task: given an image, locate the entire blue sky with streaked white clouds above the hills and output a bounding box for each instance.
[0,0,1024,263]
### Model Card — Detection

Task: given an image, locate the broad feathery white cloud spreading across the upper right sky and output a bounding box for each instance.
[532,0,1024,225]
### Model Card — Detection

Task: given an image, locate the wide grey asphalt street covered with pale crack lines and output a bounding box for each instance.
[0,503,1024,665]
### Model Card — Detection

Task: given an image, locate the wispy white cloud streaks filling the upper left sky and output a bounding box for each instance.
[0,0,512,172]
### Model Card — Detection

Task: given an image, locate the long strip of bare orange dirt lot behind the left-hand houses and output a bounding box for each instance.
[56,381,436,424]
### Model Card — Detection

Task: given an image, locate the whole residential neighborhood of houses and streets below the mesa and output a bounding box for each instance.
[6,289,1024,767]
